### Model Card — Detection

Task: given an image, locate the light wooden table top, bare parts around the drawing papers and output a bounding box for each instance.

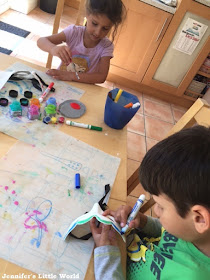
[0,54,127,280]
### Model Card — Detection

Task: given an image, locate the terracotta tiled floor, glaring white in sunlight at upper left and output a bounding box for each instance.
[0,6,186,213]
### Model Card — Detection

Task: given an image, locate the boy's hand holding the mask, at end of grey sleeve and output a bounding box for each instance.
[90,218,117,247]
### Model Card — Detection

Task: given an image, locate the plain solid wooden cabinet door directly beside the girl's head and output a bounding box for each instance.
[110,0,172,82]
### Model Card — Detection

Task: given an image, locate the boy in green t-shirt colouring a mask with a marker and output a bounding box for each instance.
[90,126,210,280]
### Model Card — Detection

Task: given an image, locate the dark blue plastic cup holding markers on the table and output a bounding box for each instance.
[104,88,140,129]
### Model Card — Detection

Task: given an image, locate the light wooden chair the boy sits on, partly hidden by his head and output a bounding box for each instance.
[127,98,210,213]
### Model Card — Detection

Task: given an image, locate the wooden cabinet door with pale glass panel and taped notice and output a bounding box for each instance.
[142,0,210,101]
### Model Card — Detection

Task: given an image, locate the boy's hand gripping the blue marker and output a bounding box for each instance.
[103,205,147,228]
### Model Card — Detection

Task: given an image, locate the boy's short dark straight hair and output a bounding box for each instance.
[139,125,210,218]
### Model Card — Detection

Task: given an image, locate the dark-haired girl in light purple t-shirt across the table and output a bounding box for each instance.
[37,0,125,83]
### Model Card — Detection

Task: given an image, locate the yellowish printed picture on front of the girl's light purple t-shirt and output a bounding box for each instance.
[66,55,90,73]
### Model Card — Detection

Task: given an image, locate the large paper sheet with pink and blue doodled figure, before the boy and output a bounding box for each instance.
[0,137,119,279]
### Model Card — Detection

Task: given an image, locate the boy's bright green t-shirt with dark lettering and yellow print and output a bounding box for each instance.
[127,229,210,280]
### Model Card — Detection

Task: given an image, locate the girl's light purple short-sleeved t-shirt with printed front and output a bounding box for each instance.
[63,25,114,73]
